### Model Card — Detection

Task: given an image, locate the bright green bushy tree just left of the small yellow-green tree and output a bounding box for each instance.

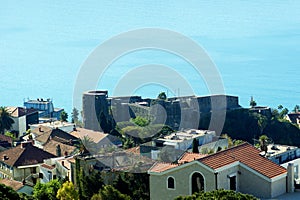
[33,179,61,200]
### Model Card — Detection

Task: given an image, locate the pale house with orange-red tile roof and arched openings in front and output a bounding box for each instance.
[148,143,293,200]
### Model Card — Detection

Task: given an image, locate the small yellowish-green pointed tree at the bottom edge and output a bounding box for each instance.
[56,181,79,200]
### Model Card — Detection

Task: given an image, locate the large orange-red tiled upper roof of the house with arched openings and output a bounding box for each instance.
[199,143,287,178]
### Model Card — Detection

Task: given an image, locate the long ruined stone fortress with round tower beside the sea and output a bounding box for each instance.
[82,90,241,132]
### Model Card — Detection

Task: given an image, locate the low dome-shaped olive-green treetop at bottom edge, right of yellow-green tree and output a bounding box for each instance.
[91,185,130,200]
